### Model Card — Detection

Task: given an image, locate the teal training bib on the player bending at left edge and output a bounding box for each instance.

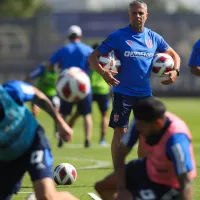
[0,82,38,160]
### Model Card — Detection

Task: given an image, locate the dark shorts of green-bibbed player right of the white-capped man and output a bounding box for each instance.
[93,94,110,113]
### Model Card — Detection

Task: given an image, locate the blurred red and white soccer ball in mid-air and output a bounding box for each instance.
[56,67,91,102]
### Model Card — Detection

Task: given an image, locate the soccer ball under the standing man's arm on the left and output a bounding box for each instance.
[99,51,121,72]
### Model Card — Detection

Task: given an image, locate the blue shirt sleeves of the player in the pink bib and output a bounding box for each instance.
[122,122,194,175]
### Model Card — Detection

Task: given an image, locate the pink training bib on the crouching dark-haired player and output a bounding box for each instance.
[140,112,196,189]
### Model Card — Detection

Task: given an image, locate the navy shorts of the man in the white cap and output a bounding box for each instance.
[60,93,92,116]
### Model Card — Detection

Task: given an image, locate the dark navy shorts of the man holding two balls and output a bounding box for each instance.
[109,93,152,128]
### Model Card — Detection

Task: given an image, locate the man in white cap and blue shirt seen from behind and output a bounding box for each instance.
[43,25,93,147]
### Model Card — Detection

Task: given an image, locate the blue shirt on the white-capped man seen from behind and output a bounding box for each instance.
[49,42,93,74]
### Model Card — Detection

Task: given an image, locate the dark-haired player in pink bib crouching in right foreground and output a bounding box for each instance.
[95,98,196,200]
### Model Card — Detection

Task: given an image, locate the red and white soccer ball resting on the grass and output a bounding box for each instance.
[53,163,77,185]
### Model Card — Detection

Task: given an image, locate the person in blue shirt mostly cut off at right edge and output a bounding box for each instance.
[188,40,200,76]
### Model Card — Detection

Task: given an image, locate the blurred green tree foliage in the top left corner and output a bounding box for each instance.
[0,0,50,18]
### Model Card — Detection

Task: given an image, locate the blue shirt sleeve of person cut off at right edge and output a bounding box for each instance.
[188,40,200,67]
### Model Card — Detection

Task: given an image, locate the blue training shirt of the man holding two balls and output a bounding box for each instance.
[98,26,169,96]
